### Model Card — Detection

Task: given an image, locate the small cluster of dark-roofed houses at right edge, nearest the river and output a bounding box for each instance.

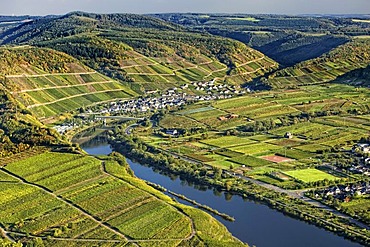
[315,182,370,202]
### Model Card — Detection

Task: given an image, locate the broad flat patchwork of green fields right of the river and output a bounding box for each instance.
[143,84,370,187]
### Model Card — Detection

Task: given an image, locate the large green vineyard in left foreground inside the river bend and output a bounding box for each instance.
[0,152,243,246]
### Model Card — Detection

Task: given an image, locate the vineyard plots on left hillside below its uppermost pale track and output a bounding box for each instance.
[10,72,136,117]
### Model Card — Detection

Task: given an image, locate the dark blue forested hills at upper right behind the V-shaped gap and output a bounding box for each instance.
[154,13,370,67]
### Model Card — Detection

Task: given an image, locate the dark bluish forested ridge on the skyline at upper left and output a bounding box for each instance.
[0,12,181,44]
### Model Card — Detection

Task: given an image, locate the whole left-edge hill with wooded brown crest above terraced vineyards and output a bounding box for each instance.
[0,46,136,119]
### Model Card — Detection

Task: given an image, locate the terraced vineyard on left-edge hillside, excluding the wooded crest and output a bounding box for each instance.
[1,48,136,118]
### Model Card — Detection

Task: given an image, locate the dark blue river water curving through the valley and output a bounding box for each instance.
[81,143,361,247]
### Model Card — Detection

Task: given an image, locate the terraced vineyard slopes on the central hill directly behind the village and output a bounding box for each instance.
[121,42,277,90]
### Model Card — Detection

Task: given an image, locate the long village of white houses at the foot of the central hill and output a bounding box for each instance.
[54,80,251,134]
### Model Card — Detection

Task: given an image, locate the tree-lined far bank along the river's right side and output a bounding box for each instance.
[111,133,369,247]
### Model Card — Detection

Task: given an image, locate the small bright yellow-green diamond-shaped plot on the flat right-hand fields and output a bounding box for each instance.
[284,168,339,183]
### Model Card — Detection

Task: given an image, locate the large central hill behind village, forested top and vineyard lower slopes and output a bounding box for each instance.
[0,12,278,93]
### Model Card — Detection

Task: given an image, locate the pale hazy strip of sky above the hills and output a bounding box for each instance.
[0,0,370,15]
